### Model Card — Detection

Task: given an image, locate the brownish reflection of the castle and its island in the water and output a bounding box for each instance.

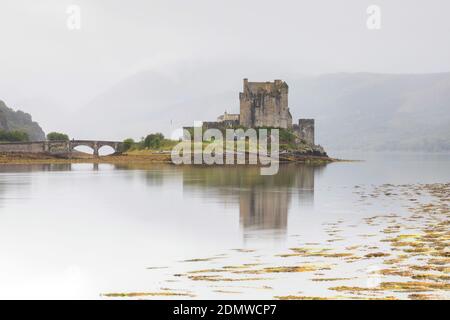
[179,164,324,234]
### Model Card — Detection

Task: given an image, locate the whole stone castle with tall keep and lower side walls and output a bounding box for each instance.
[194,79,315,145]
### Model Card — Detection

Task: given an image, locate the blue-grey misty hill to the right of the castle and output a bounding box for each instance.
[291,73,450,151]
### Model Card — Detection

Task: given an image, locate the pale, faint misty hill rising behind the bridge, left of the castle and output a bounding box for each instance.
[77,71,240,139]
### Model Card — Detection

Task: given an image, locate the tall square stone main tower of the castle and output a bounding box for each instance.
[239,79,292,129]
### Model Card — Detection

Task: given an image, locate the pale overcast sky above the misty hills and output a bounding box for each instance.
[0,0,450,132]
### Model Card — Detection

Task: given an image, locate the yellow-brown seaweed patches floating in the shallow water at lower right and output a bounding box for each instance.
[105,183,450,300]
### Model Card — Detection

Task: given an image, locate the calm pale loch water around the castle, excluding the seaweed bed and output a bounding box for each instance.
[0,154,450,299]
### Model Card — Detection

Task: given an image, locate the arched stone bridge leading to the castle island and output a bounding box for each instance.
[0,140,124,156]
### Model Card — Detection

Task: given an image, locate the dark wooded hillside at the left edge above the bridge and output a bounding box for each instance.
[0,100,45,141]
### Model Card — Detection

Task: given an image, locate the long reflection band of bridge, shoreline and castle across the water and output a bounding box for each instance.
[0,163,324,240]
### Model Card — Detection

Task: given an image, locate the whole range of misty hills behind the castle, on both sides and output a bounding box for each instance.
[79,70,450,151]
